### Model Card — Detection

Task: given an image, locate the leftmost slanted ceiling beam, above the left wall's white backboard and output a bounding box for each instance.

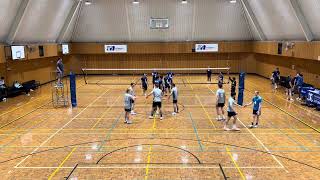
[6,0,30,45]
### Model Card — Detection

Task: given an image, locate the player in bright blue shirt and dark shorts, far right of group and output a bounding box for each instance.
[244,91,262,128]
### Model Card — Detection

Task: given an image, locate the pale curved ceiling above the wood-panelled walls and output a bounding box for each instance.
[0,0,320,44]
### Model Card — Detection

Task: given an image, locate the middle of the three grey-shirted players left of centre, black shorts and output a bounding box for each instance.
[146,84,163,120]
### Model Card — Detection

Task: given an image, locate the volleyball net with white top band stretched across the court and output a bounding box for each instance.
[82,67,230,85]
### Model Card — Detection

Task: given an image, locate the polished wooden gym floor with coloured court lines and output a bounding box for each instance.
[0,75,320,180]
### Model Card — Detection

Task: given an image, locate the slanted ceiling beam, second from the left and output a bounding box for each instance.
[56,0,82,43]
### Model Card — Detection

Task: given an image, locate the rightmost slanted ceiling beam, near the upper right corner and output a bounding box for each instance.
[290,0,314,42]
